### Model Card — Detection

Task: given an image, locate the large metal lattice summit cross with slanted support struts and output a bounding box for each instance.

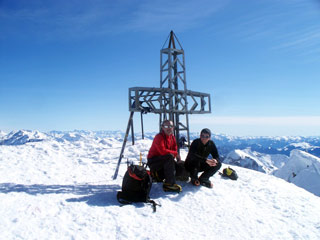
[113,31,211,179]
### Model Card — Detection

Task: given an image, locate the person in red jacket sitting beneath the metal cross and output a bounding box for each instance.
[147,120,182,192]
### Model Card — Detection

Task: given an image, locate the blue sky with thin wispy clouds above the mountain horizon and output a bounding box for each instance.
[0,0,320,136]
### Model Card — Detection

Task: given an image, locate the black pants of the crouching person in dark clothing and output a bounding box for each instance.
[184,157,221,180]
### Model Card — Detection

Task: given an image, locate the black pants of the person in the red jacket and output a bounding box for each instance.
[148,154,177,184]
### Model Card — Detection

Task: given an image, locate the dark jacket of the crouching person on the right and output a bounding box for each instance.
[186,138,220,162]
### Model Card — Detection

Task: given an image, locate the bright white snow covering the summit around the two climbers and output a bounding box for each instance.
[0,131,320,240]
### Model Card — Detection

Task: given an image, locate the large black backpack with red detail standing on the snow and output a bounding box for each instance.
[117,164,159,212]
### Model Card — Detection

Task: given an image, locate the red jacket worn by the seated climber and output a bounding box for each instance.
[147,132,178,159]
